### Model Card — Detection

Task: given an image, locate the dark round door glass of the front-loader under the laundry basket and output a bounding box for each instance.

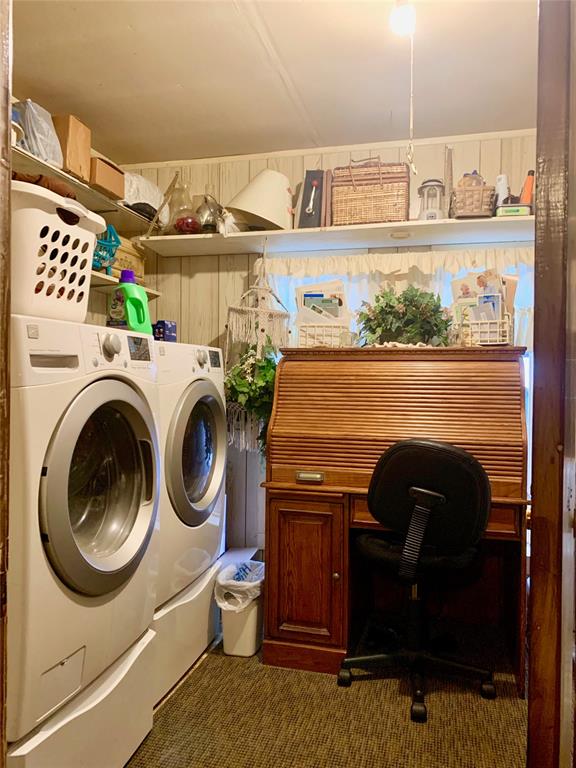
[68,405,144,557]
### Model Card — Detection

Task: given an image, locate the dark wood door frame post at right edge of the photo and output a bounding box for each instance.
[528,0,576,768]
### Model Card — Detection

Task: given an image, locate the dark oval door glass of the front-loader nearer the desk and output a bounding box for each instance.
[182,399,218,504]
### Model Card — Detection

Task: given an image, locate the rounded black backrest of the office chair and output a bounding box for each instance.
[368,439,491,555]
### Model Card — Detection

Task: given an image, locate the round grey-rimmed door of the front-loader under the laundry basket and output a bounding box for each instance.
[40,379,159,595]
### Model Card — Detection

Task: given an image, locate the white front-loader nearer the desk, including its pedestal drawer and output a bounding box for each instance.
[152,342,227,701]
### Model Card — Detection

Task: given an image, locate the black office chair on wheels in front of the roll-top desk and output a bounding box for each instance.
[338,440,496,722]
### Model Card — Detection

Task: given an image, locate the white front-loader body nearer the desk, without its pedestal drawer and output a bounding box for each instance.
[156,342,227,606]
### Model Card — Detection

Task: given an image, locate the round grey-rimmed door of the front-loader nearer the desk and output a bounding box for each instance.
[164,379,226,526]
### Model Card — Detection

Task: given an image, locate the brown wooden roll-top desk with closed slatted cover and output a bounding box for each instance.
[263,347,527,692]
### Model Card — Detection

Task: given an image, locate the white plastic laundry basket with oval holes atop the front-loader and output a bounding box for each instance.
[11,181,106,323]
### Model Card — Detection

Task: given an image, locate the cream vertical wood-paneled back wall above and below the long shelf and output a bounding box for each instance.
[88,130,536,546]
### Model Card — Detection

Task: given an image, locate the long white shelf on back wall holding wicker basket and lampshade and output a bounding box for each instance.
[140,216,534,256]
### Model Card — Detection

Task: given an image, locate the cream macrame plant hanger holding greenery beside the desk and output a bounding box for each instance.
[225,242,290,451]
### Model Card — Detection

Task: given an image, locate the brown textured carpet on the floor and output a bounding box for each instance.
[128,649,527,768]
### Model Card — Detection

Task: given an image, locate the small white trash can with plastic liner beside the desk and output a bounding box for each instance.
[214,560,264,656]
